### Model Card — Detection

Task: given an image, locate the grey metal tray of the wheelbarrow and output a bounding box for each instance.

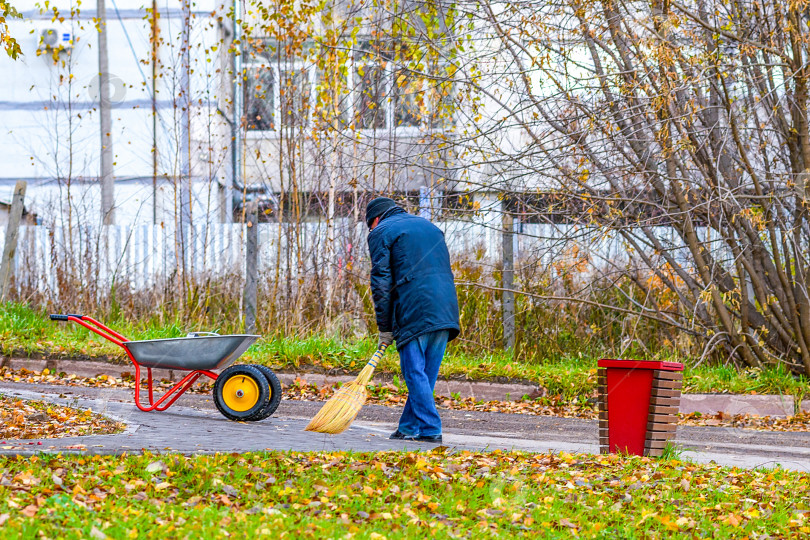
[124,334,259,371]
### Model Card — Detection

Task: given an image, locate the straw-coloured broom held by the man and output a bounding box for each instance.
[304,344,388,435]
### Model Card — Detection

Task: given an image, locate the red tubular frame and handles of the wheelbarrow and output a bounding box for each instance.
[51,314,217,412]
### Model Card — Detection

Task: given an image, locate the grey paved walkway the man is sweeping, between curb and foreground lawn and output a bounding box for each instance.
[0,382,810,472]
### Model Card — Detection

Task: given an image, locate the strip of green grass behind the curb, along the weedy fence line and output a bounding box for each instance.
[0,303,810,400]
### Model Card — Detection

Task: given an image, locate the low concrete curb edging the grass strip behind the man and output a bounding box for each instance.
[0,358,810,418]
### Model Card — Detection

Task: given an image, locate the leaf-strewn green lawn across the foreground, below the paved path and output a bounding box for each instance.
[0,449,810,538]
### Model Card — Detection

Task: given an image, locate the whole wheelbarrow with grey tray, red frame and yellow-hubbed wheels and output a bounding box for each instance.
[51,314,281,421]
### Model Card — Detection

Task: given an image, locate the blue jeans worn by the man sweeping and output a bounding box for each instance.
[397,330,450,437]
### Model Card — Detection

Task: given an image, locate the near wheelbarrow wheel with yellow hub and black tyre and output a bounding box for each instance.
[214,365,270,421]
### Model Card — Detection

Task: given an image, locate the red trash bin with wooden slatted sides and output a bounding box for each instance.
[598,358,683,456]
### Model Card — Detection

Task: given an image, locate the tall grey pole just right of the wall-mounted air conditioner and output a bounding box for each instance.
[96,0,115,225]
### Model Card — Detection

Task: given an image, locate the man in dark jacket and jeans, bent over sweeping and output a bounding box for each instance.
[366,197,460,443]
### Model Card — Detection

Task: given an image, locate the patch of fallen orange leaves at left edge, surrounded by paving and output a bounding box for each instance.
[0,395,124,439]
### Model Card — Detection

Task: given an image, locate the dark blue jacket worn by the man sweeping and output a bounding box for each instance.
[368,207,460,347]
